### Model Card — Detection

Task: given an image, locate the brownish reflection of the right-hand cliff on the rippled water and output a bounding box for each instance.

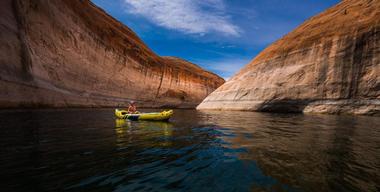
[196,111,380,191]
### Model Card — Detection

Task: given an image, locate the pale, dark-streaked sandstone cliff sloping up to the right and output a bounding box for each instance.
[197,0,380,114]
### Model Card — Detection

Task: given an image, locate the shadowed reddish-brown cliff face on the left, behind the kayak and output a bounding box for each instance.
[0,0,224,108]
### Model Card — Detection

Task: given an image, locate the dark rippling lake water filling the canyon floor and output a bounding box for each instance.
[0,109,380,192]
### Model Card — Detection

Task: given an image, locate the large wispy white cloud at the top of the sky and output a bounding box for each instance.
[124,0,241,36]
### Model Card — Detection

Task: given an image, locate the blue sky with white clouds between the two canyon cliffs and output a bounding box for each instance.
[92,0,340,79]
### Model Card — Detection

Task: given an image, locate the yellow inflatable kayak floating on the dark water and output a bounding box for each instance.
[115,109,173,121]
